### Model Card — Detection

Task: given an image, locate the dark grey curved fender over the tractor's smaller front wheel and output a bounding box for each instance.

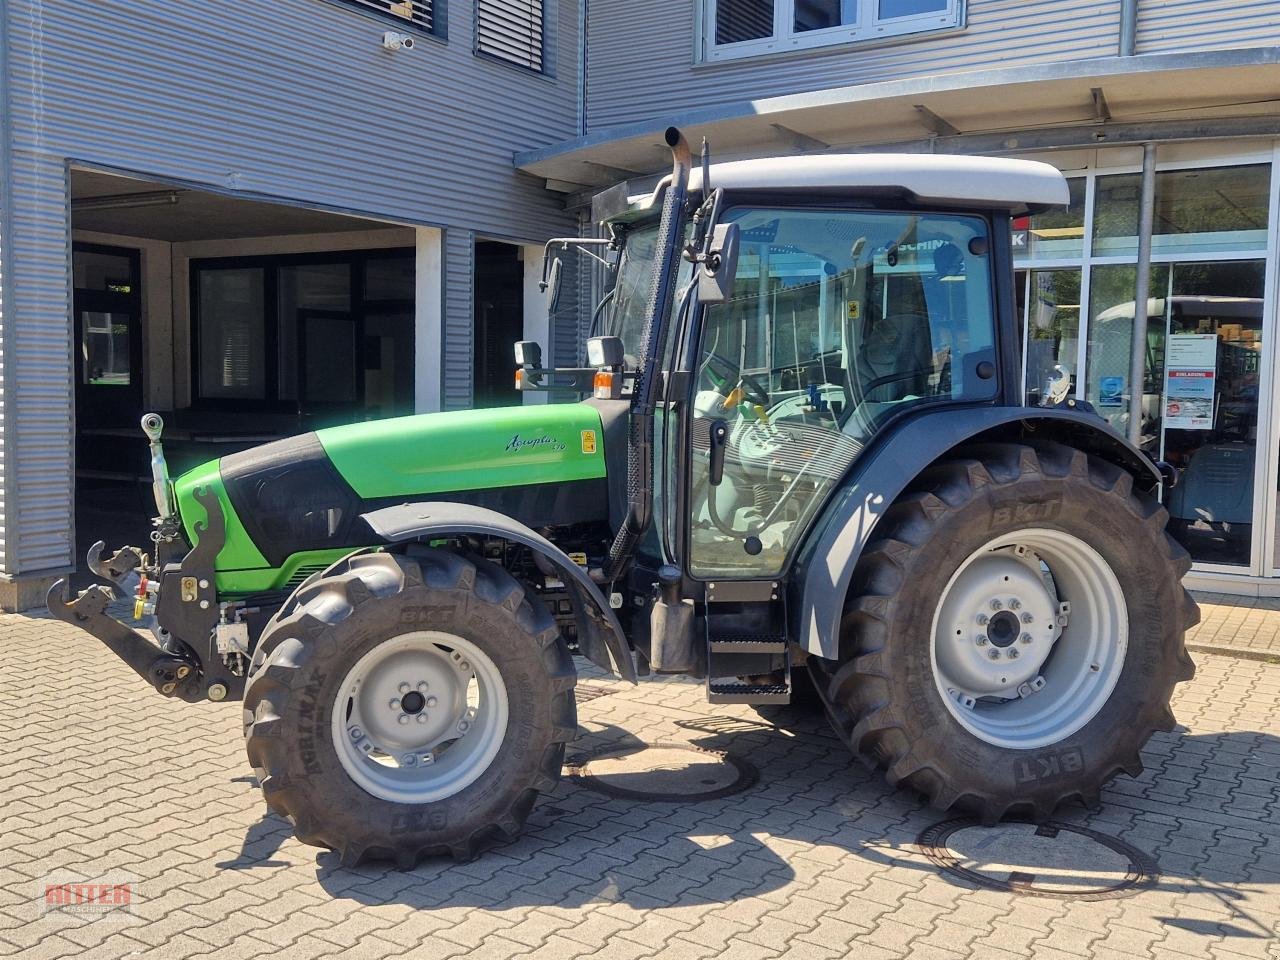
[362,502,636,684]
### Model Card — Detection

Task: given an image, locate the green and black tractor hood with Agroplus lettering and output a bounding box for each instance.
[174,403,608,593]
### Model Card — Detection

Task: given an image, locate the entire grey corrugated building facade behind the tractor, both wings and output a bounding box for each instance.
[0,0,1280,608]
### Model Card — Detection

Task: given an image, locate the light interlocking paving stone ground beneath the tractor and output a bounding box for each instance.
[0,603,1280,960]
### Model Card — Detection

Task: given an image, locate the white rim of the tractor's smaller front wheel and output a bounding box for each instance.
[333,630,508,804]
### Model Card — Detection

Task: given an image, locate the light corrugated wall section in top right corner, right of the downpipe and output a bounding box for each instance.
[1135,0,1280,54]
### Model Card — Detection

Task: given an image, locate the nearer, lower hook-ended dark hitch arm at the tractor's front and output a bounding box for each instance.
[47,580,204,703]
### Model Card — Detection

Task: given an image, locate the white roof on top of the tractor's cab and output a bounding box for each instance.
[655,154,1069,212]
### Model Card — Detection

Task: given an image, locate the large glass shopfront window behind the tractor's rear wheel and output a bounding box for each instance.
[1014,163,1276,572]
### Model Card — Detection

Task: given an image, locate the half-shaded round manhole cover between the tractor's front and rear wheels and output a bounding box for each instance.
[566,744,756,804]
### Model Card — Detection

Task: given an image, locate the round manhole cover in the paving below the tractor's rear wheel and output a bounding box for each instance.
[918,819,1158,900]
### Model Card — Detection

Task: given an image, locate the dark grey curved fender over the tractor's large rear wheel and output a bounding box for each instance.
[791,407,1161,659]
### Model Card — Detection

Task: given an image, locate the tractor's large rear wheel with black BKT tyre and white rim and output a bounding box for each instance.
[823,443,1199,822]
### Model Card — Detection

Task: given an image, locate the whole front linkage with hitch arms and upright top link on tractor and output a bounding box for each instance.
[47,424,238,703]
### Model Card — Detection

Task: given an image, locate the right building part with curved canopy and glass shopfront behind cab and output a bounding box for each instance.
[517,0,1280,594]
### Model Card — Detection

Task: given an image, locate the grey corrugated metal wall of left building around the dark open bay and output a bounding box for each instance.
[0,0,577,573]
